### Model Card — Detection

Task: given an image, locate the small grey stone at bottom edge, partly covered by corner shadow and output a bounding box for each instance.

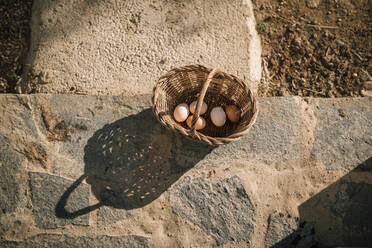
[265,213,318,248]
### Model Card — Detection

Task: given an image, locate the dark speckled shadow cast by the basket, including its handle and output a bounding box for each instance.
[56,109,213,218]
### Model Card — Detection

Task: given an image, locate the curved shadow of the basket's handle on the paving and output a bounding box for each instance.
[55,174,103,219]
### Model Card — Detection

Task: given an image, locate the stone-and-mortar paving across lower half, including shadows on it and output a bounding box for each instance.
[0,95,372,247]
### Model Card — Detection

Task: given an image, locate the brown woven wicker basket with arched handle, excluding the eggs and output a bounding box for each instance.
[152,65,258,146]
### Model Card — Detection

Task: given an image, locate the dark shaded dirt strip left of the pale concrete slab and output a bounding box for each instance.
[0,0,32,93]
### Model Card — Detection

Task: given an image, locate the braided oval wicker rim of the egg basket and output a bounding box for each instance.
[152,64,258,146]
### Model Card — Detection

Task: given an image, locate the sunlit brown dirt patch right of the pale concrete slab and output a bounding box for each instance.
[253,0,372,97]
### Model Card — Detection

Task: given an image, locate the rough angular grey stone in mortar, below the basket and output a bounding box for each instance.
[170,177,255,245]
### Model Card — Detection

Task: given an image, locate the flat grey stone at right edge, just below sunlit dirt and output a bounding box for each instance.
[311,98,372,170]
